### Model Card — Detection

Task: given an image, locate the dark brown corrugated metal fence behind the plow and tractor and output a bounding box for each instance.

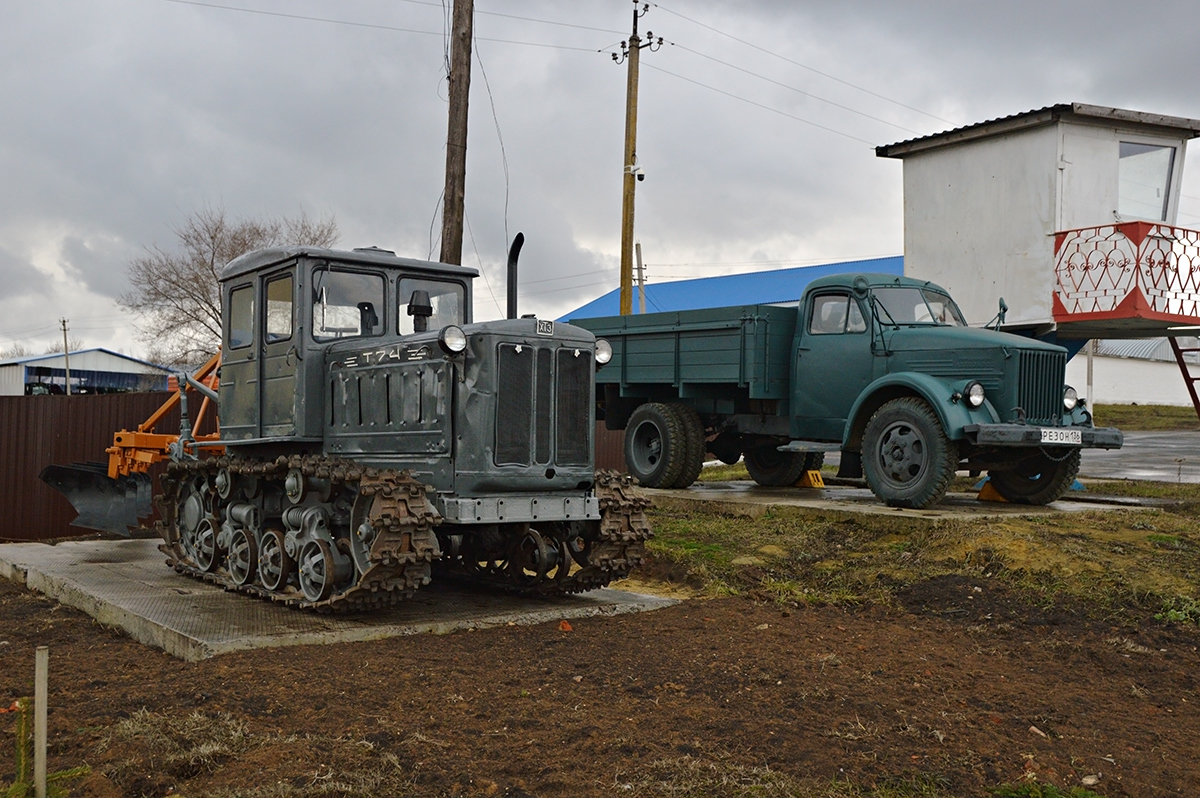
[0,391,625,541]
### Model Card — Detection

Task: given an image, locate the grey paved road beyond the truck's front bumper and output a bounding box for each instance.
[1079,432,1200,482]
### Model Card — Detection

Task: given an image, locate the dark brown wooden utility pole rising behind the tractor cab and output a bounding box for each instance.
[442,0,475,265]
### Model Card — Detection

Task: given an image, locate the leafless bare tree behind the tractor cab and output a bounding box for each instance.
[116,208,340,364]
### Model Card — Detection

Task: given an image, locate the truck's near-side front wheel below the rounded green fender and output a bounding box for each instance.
[863,396,959,510]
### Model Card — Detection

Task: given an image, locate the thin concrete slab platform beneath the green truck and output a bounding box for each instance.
[642,481,1162,518]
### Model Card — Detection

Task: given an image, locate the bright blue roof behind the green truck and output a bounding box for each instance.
[558,256,904,322]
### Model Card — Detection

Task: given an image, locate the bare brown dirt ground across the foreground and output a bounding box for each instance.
[0,559,1200,797]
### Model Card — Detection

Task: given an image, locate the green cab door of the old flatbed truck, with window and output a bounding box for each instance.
[792,290,875,440]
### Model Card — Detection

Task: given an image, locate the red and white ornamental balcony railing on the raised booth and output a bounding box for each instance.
[1054,222,1200,323]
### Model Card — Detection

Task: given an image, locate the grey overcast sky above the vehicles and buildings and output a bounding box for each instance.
[0,0,1200,354]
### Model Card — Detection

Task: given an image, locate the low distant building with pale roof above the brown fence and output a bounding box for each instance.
[0,348,170,396]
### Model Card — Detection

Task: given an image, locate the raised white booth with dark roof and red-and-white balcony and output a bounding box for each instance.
[876,103,1200,342]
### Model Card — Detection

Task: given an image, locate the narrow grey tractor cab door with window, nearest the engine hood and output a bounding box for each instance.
[260,270,300,438]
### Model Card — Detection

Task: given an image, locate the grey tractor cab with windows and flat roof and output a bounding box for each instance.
[220,247,478,449]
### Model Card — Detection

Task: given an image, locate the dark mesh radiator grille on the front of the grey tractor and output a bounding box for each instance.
[496,343,593,466]
